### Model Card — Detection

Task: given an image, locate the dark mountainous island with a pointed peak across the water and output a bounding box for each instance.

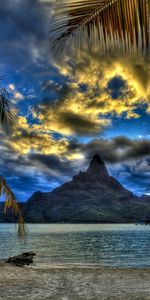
[0,155,150,223]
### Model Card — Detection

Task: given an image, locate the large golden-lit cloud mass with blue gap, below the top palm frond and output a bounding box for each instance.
[30,55,150,136]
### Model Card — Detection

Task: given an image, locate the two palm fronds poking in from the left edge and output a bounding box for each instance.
[0,83,26,238]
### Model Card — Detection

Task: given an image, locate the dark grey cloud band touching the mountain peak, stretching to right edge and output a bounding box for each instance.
[69,137,150,163]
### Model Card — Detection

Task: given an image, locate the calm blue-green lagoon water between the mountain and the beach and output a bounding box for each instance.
[0,224,150,268]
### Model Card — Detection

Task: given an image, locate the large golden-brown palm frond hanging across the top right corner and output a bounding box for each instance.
[50,0,150,55]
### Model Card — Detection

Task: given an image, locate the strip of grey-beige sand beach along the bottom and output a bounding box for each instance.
[0,263,150,300]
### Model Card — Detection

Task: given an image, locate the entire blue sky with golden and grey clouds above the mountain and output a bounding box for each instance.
[0,0,150,201]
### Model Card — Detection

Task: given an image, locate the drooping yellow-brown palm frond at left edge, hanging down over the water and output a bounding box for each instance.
[0,176,27,238]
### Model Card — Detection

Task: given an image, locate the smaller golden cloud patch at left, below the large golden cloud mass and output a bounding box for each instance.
[5,116,68,155]
